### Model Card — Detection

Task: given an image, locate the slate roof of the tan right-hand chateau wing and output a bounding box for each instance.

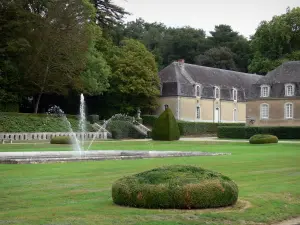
[250,61,300,99]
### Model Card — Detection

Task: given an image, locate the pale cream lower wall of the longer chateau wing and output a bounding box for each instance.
[156,96,246,123]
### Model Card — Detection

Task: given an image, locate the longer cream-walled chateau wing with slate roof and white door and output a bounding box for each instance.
[156,60,261,123]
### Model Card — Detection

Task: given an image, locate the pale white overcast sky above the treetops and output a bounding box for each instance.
[113,0,300,38]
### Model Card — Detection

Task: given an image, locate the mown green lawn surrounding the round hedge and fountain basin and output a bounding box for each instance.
[0,141,300,225]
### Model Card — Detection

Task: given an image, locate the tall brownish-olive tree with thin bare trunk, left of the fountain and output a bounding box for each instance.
[15,0,93,113]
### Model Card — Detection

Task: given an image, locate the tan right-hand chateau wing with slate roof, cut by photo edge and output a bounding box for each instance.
[247,61,300,126]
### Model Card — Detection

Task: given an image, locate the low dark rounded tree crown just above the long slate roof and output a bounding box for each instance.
[195,47,236,70]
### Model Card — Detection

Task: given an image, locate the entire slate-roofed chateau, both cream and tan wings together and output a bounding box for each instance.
[156,60,300,126]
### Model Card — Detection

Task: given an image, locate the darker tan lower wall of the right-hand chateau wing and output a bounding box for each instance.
[247,98,300,126]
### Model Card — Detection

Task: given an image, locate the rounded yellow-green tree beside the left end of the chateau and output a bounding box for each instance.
[109,39,159,113]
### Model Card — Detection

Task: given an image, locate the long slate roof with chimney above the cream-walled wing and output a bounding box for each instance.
[159,62,261,101]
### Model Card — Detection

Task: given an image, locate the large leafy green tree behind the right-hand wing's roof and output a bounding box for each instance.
[249,7,300,74]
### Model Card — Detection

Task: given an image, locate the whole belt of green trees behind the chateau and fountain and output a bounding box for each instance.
[0,0,300,116]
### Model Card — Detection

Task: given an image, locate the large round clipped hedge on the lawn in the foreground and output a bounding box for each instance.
[112,165,238,209]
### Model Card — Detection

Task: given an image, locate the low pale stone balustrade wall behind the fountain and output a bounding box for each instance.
[0,132,107,141]
